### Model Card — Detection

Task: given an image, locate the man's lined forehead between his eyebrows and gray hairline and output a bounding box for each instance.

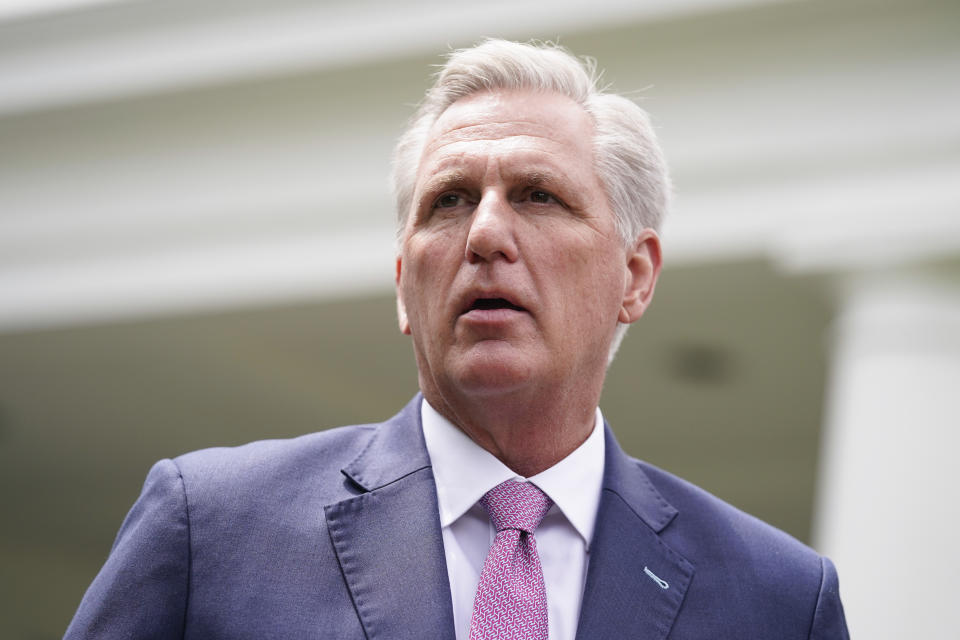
[420,91,593,177]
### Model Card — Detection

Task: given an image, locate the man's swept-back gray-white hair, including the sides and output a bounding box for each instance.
[391,39,670,360]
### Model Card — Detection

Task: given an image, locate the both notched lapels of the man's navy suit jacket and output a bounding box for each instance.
[324,402,694,640]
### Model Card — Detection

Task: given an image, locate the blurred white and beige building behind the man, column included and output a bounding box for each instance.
[0,0,960,639]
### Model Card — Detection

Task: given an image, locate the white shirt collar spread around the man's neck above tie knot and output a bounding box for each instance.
[420,399,604,548]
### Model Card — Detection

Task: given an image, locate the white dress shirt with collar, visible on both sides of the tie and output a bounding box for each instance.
[421,400,604,640]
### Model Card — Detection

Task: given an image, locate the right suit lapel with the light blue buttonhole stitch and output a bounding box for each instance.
[577,426,694,640]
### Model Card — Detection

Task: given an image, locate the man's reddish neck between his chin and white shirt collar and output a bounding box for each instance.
[424,382,599,477]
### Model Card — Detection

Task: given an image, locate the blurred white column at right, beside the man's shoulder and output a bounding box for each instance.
[814,274,960,640]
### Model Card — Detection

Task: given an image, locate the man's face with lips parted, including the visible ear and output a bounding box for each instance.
[397,91,659,401]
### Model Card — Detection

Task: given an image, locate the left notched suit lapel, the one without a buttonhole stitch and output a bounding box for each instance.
[324,395,454,640]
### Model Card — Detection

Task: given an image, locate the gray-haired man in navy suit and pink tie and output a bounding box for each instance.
[67,41,847,640]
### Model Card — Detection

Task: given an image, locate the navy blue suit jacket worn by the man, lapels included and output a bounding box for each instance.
[66,396,848,640]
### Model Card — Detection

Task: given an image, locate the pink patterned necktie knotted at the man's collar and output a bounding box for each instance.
[470,480,553,640]
